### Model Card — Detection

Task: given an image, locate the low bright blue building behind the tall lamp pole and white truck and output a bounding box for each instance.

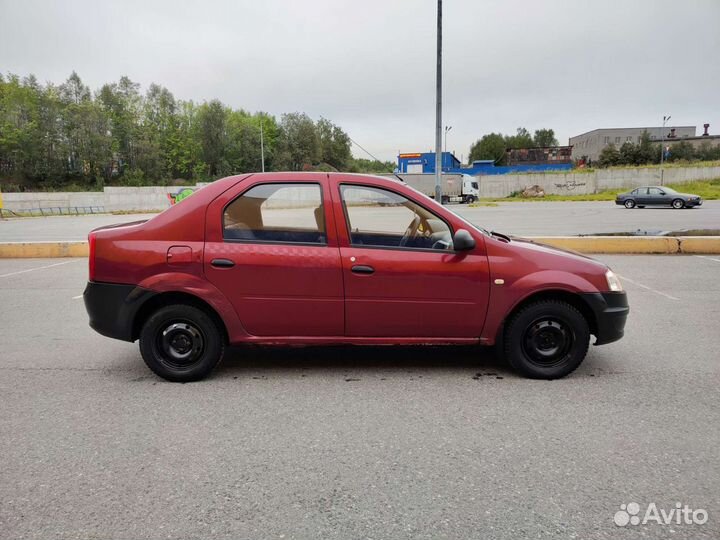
[396,152,573,176]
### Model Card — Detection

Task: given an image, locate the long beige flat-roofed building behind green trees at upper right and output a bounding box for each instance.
[570,126,695,161]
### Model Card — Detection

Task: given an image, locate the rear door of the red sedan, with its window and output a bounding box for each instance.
[204,174,344,337]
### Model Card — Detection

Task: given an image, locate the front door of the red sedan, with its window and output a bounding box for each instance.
[333,183,489,338]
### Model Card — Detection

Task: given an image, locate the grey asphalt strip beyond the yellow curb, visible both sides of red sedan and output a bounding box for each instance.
[0,201,720,242]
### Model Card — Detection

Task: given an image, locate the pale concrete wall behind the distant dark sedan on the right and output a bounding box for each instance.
[477,166,720,198]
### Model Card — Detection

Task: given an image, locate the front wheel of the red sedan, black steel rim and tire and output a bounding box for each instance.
[504,300,590,379]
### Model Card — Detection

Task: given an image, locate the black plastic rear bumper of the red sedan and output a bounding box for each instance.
[83,281,155,341]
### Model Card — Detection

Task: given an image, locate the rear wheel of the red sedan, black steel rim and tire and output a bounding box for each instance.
[140,304,225,382]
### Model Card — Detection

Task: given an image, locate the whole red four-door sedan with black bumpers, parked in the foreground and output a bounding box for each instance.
[84,173,629,381]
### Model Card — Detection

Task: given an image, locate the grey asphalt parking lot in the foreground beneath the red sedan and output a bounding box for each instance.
[0,255,720,540]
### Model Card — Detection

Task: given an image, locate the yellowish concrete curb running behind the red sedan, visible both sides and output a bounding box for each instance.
[0,236,720,259]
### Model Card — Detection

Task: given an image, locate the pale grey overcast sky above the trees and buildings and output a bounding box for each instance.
[0,0,720,161]
